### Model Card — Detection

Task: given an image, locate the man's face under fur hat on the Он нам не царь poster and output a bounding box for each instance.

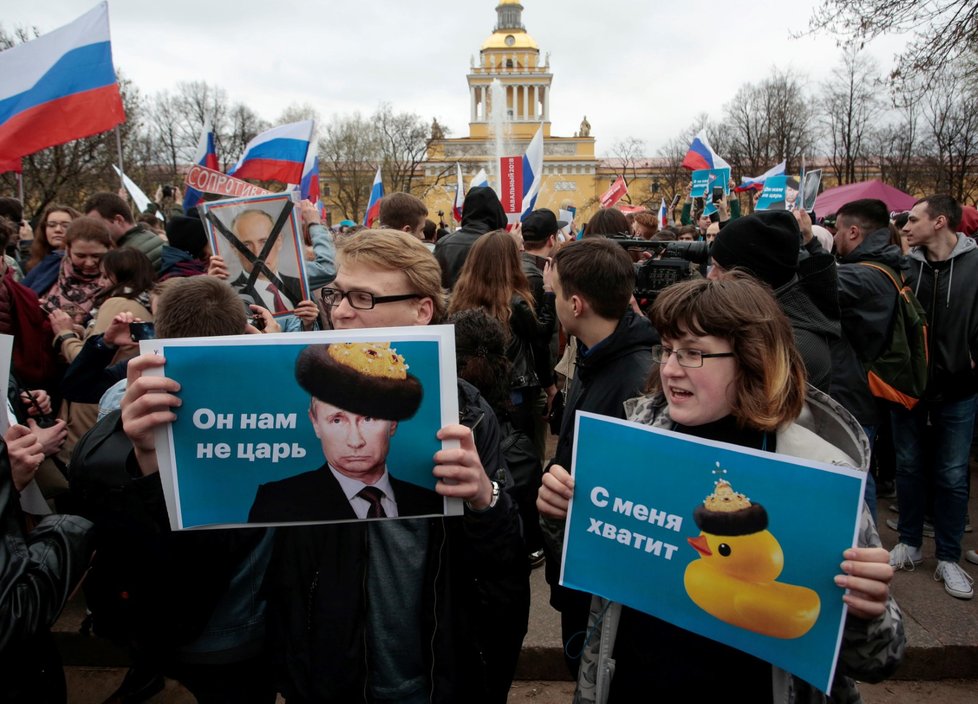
[309,398,397,484]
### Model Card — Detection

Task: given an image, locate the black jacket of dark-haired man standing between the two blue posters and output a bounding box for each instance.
[546,311,659,616]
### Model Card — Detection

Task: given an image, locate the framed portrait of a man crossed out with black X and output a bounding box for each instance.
[198,191,309,315]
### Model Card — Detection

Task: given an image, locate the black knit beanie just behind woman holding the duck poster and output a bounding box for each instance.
[710,210,801,288]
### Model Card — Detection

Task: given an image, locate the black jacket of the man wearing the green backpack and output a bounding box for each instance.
[829,228,907,425]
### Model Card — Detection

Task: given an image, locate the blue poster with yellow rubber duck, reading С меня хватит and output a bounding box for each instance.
[561,413,864,691]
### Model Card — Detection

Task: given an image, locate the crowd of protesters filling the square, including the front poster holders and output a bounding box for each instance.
[0,180,978,704]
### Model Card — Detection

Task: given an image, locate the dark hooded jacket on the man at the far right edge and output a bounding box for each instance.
[908,234,978,403]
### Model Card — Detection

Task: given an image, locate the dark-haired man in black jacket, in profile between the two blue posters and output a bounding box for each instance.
[537,237,659,677]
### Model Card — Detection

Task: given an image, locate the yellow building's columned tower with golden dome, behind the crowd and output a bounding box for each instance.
[424,0,608,222]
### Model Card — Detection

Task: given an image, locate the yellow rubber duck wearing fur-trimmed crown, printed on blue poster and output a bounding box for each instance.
[683,479,821,638]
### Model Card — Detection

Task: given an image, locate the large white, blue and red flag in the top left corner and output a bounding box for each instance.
[0,2,126,161]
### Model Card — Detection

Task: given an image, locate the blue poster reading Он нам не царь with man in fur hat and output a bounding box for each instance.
[141,326,462,530]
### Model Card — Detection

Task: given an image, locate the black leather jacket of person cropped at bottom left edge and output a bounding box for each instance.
[0,446,92,702]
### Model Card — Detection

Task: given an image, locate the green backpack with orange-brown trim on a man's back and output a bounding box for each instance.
[859,262,928,410]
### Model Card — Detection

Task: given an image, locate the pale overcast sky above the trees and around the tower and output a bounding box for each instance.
[2,0,902,155]
